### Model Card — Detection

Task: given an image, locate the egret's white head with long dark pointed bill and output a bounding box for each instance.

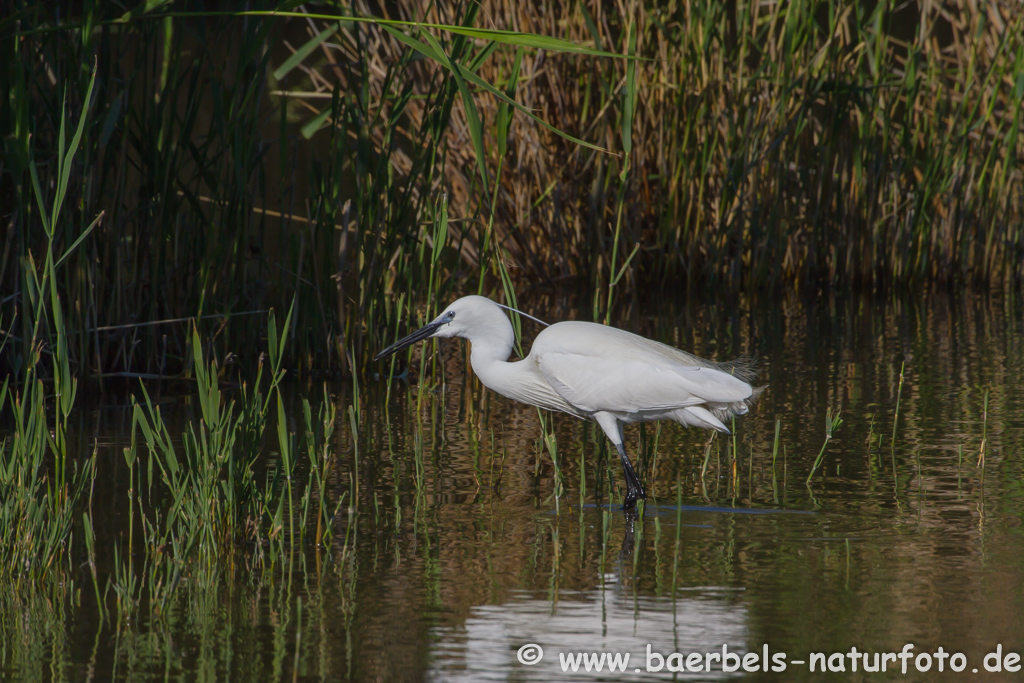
[374,296,515,360]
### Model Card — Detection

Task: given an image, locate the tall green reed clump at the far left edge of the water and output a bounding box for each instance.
[0,68,98,587]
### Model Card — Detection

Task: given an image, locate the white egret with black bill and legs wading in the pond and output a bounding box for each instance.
[374,296,759,509]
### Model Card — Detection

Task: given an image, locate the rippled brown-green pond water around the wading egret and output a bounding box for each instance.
[0,286,1024,681]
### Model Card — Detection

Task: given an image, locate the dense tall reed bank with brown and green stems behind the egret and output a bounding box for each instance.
[0,0,1024,387]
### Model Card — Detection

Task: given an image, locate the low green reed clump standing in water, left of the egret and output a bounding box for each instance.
[103,311,311,623]
